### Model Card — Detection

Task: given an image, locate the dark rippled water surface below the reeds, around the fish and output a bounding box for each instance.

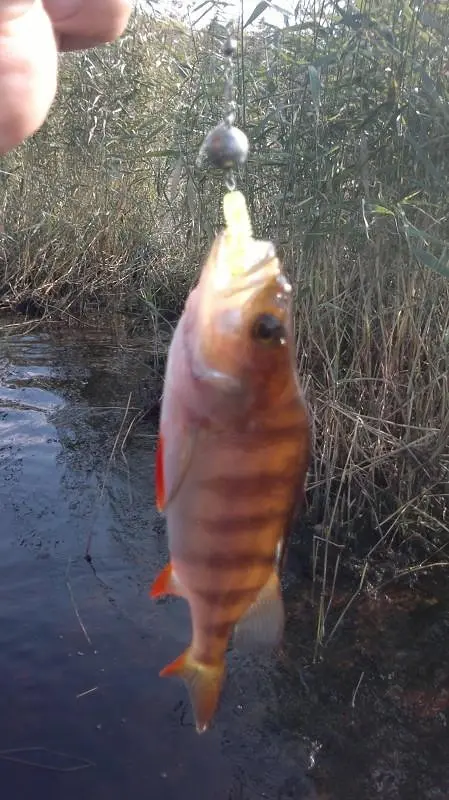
[0,316,449,800]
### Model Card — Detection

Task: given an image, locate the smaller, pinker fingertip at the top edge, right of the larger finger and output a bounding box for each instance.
[44,0,132,50]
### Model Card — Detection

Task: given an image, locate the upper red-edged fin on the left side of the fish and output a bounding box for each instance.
[156,428,197,512]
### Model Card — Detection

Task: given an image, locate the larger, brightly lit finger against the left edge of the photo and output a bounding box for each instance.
[0,0,57,155]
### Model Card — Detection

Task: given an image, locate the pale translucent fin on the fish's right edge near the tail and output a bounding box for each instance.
[233,570,285,651]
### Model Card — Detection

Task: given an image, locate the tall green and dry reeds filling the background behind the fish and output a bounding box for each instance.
[0,0,449,639]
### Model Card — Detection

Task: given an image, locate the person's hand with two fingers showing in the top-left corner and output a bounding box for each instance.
[0,0,131,155]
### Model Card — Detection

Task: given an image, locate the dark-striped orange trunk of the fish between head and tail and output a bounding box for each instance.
[162,332,308,663]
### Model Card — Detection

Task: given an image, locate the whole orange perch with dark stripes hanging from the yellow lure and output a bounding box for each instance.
[150,189,311,733]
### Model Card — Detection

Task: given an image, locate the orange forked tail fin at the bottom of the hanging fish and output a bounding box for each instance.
[159,647,226,733]
